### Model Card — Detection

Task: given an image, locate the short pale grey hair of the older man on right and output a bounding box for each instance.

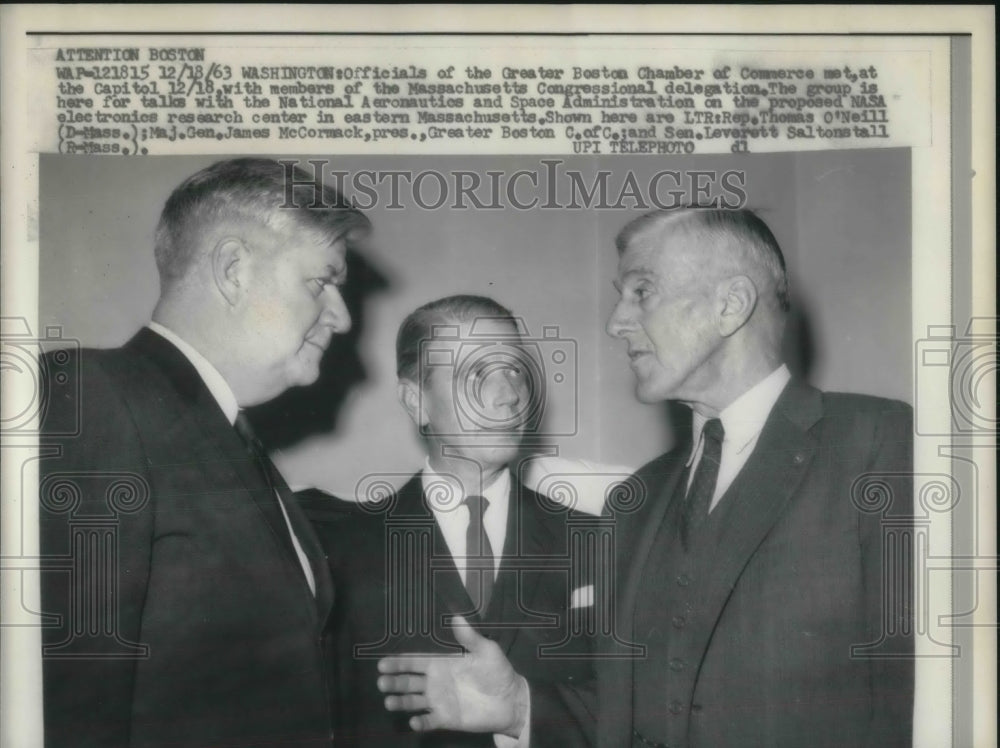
[615,208,791,312]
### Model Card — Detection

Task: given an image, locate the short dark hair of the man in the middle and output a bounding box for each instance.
[396,294,517,384]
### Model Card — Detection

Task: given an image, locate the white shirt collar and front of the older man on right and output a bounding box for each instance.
[687,364,792,512]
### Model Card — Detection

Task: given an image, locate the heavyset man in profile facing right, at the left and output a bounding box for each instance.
[40,159,367,746]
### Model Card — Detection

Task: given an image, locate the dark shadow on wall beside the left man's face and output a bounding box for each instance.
[248,250,390,449]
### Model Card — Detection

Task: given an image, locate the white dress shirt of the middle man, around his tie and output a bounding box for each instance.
[420,459,510,584]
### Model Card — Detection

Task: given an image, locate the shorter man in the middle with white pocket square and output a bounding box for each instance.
[320,296,591,747]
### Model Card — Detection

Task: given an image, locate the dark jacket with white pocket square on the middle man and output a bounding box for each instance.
[311,475,592,748]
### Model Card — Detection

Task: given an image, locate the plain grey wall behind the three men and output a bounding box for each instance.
[39,149,912,497]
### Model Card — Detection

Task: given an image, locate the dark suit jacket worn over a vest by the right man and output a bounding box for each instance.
[532,382,913,748]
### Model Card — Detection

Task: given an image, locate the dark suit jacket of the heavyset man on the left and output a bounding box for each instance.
[40,329,333,747]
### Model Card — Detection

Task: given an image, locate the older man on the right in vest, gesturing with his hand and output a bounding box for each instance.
[380,209,913,748]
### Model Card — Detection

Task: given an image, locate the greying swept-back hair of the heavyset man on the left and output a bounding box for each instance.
[154,158,370,284]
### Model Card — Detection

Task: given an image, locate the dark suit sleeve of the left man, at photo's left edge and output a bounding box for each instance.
[39,354,153,747]
